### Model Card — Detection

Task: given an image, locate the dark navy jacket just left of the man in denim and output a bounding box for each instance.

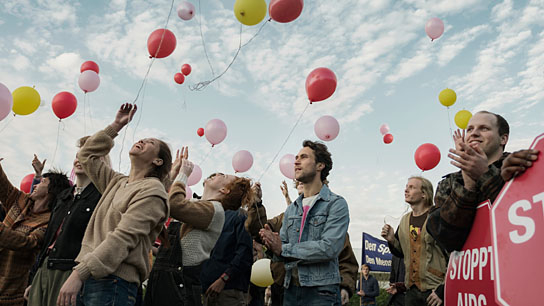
[200,210,253,292]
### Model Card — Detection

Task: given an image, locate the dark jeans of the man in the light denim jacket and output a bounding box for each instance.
[283,282,342,306]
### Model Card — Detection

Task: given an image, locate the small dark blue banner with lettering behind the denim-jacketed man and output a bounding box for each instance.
[362,233,392,272]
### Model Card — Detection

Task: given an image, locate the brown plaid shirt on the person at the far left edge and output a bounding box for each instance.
[0,165,50,305]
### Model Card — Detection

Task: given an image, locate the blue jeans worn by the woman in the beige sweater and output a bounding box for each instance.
[77,275,138,306]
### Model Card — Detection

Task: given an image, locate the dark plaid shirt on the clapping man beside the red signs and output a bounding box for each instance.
[427,152,510,252]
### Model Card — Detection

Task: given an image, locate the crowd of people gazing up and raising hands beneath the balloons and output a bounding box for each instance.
[0,104,539,306]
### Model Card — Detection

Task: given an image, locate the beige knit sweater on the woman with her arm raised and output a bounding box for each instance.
[74,126,169,283]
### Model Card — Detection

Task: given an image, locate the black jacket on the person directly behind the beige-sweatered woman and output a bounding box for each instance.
[38,183,101,271]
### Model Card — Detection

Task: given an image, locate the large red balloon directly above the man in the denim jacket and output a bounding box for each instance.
[306,67,336,103]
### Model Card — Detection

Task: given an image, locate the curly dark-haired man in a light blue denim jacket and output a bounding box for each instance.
[261,140,349,306]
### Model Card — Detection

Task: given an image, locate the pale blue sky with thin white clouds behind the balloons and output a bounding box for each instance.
[0,0,544,257]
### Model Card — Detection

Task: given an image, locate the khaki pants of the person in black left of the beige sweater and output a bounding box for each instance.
[28,257,72,306]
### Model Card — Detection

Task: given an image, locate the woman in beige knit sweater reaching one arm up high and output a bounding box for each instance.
[57,103,172,306]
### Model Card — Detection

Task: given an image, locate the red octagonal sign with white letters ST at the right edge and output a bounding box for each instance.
[491,134,544,305]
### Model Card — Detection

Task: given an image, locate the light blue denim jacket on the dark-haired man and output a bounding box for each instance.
[280,185,349,288]
